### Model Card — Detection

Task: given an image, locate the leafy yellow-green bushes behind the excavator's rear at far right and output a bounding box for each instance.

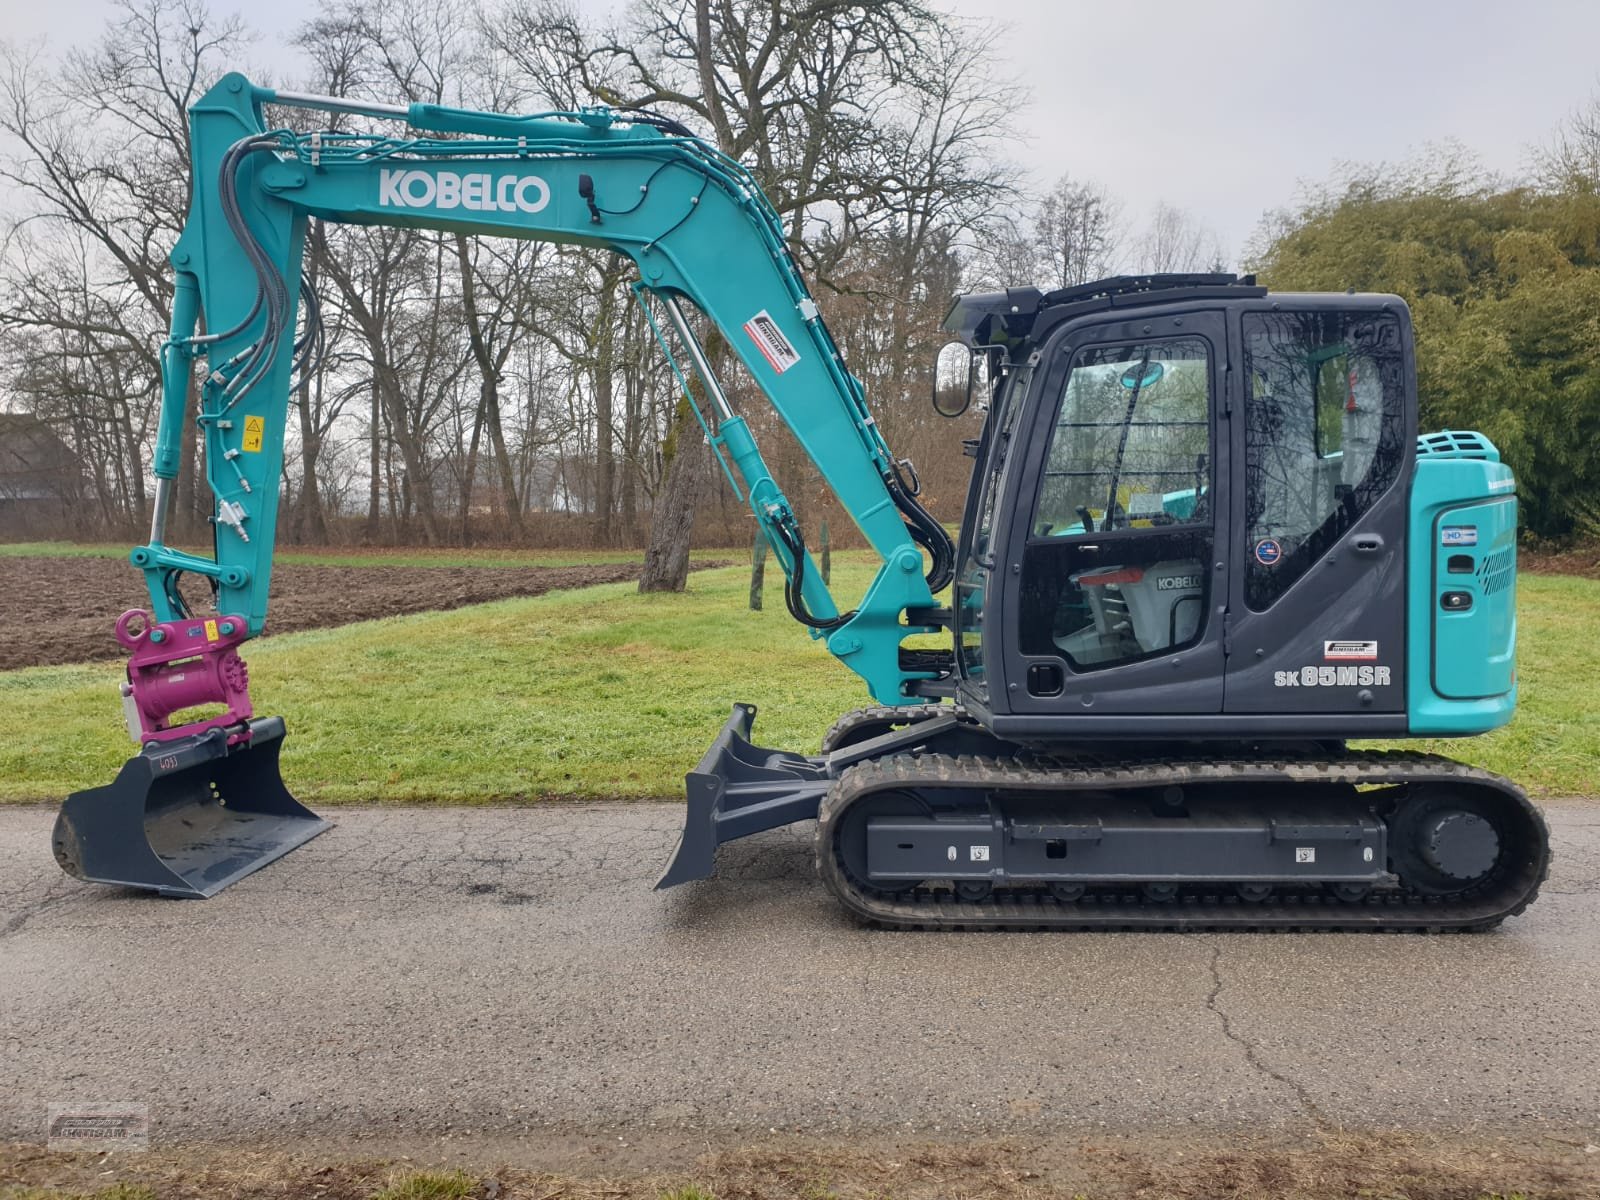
[1246,124,1600,542]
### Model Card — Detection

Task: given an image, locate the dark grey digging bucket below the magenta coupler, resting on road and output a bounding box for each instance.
[54,717,328,898]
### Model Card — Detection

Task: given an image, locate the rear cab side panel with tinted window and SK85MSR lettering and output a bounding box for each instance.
[1224,305,1416,715]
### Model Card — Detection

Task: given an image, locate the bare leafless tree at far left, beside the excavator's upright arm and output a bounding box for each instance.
[0,0,248,533]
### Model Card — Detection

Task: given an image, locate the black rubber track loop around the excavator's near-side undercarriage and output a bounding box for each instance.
[816,752,1550,933]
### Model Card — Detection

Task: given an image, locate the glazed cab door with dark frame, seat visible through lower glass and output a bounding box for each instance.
[994,310,1230,717]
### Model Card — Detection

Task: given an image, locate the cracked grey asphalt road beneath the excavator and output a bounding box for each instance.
[0,803,1600,1141]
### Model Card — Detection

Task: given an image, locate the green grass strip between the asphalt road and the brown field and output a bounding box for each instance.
[0,566,1600,803]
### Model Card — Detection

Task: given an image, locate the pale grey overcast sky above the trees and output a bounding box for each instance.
[9,0,1600,267]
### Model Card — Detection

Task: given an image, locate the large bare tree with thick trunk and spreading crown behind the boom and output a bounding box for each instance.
[496,0,1002,590]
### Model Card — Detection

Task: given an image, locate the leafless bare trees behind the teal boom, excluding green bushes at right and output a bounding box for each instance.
[0,0,1235,579]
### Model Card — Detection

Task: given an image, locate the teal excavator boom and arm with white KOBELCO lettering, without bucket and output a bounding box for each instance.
[133,75,952,732]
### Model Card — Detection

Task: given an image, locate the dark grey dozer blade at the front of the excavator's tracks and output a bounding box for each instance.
[656,704,832,888]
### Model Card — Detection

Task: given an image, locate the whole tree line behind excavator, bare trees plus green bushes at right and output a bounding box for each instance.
[0,0,1600,569]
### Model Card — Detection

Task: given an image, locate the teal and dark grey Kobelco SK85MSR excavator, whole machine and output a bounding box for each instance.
[54,74,1550,931]
